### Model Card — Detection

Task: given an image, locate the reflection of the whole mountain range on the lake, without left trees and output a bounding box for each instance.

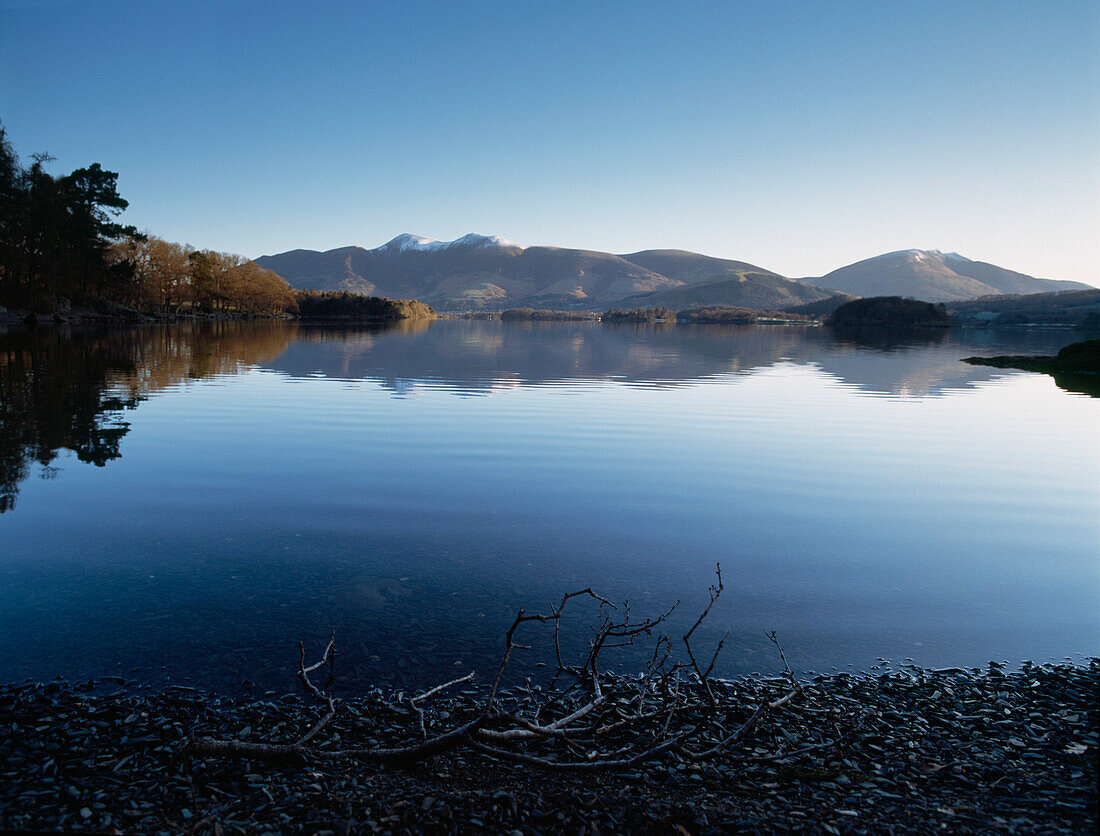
[266,320,1066,397]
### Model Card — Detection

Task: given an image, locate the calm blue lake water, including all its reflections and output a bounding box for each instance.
[0,321,1100,690]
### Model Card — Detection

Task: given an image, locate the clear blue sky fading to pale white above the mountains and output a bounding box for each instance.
[0,0,1100,284]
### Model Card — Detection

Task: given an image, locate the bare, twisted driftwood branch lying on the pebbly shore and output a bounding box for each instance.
[183,567,853,772]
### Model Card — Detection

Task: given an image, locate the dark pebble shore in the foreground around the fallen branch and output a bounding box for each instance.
[0,660,1100,836]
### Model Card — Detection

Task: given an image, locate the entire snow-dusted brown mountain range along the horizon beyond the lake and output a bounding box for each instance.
[255,233,1087,310]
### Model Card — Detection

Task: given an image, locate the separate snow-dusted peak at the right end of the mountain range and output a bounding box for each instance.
[804,250,1088,301]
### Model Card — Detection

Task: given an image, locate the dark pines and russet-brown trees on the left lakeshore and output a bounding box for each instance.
[0,125,294,315]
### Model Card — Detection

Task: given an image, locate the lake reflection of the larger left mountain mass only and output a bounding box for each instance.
[267,320,802,394]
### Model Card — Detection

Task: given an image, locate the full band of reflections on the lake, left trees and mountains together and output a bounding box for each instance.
[0,320,1082,513]
